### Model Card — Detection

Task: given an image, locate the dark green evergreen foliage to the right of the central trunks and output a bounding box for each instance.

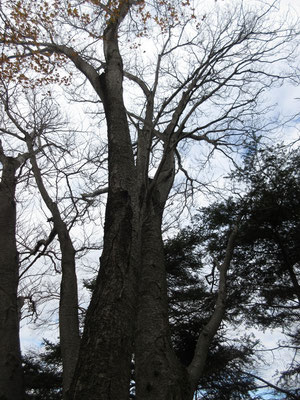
[20,143,299,399]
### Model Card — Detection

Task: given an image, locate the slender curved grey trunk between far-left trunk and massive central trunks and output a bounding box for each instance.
[26,141,80,398]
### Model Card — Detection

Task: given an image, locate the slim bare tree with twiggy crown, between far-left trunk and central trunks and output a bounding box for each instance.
[0,82,103,391]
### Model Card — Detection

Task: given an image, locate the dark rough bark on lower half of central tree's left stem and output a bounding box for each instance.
[72,191,136,400]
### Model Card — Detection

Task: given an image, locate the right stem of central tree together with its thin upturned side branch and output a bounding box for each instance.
[135,142,239,400]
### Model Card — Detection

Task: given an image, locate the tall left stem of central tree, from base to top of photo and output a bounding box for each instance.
[70,7,139,400]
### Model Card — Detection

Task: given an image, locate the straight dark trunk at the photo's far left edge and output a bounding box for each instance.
[0,154,23,400]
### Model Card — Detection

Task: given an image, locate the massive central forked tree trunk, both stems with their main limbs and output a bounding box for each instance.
[53,1,239,400]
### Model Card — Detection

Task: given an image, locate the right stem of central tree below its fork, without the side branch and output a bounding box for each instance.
[135,207,190,400]
